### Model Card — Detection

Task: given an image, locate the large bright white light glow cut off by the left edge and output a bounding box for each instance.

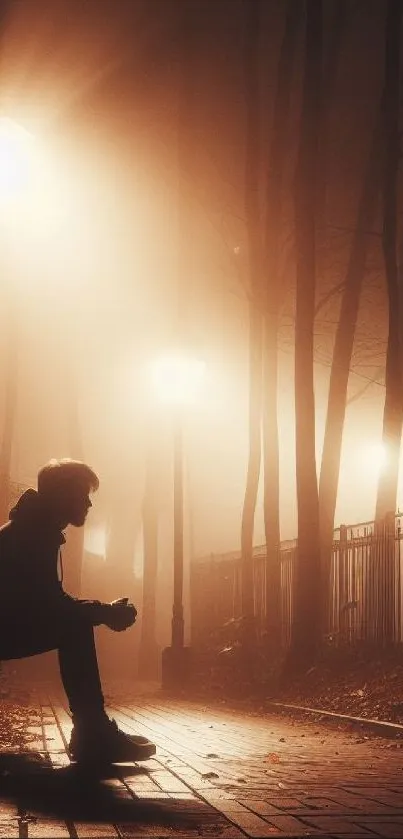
[0,117,35,200]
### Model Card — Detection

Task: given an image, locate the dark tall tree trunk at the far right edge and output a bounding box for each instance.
[371,0,403,644]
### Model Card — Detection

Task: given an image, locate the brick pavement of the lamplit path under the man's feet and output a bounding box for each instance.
[0,693,403,839]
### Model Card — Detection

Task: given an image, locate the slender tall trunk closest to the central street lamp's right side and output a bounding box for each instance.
[241,0,262,627]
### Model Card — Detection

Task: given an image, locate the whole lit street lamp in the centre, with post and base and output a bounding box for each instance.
[152,354,205,688]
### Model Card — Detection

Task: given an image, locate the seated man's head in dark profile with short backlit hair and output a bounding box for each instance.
[38,457,99,530]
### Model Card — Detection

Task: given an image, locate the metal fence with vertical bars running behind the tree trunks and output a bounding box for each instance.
[191,515,403,646]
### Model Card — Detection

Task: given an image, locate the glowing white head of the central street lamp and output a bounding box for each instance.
[151,354,206,405]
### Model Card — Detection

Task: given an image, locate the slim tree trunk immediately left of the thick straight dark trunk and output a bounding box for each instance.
[263,0,300,650]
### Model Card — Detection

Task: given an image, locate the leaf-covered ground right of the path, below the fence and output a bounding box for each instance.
[189,644,403,724]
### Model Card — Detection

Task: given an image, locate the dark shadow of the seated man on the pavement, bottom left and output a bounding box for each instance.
[0,752,218,832]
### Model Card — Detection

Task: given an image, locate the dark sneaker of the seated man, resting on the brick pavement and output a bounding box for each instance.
[69,720,156,764]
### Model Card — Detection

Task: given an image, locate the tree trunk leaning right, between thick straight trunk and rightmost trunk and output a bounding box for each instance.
[319,103,382,630]
